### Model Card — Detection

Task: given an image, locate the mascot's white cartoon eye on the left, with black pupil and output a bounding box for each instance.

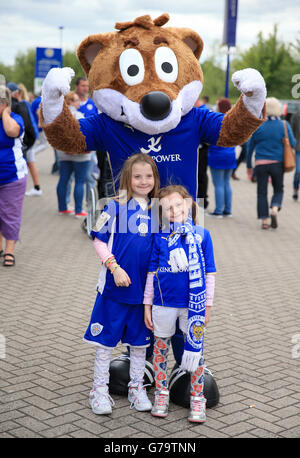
[119,48,145,86]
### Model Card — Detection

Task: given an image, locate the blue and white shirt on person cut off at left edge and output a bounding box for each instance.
[0,112,27,186]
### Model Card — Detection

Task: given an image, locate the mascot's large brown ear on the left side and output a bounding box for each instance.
[77,32,114,76]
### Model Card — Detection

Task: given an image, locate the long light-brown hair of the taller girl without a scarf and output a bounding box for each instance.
[115,153,160,203]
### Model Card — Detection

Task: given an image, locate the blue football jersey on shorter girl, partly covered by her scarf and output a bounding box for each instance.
[148,226,216,308]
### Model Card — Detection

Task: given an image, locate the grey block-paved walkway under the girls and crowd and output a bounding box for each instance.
[0,148,300,439]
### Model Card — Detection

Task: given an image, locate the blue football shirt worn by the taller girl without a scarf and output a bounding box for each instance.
[91,198,155,304]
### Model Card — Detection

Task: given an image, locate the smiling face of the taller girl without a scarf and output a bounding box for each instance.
[131,162,154,199]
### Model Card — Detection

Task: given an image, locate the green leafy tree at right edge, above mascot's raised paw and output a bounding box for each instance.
[232,25,297,99]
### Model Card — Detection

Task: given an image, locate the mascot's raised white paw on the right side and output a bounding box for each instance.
[232,68,267,118]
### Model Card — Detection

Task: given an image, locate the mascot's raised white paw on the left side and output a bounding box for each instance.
[42,67,75,124]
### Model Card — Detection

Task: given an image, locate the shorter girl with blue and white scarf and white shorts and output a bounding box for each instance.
[144,186,216,423]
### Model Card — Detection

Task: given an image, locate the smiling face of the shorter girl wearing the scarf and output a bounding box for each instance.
[160,192,192,223]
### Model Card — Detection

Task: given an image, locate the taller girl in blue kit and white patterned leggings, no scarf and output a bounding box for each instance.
[84,154,160,414]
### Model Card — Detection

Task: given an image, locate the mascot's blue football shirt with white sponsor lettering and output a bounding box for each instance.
[79,108,224,199]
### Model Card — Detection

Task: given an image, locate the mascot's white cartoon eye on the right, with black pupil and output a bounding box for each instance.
[155,46,178,83]
